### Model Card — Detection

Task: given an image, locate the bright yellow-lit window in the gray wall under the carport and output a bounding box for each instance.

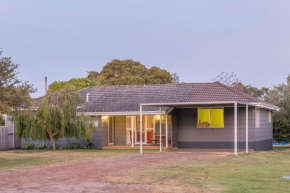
[197,109,224,128]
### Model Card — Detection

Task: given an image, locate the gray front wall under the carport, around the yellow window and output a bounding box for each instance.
[177,107,255,149]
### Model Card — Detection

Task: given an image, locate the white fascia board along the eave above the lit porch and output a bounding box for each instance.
[77,111,165,116]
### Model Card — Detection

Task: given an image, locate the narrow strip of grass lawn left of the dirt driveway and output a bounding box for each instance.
[0,149,157,172]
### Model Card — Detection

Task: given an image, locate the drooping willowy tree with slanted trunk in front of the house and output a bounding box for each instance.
[14,89,96,150]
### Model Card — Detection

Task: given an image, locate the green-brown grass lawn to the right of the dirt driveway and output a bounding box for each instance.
[106,148,290,193]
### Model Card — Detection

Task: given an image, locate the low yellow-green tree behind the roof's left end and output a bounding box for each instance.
[49,78,98,92]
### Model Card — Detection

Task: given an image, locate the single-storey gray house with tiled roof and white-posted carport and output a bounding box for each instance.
[79,82,279,154]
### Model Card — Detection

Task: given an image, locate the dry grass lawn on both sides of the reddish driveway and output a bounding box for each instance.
[0,148,290,193]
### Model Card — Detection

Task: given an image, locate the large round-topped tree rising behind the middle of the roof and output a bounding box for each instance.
[87,60,172,86]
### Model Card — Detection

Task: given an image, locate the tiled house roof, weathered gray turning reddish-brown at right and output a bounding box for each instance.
[78,82,278,112]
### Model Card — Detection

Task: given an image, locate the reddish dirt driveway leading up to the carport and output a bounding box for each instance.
[0,151,231,193]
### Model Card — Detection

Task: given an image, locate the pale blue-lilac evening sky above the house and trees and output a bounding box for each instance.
[0,0,290,97]
